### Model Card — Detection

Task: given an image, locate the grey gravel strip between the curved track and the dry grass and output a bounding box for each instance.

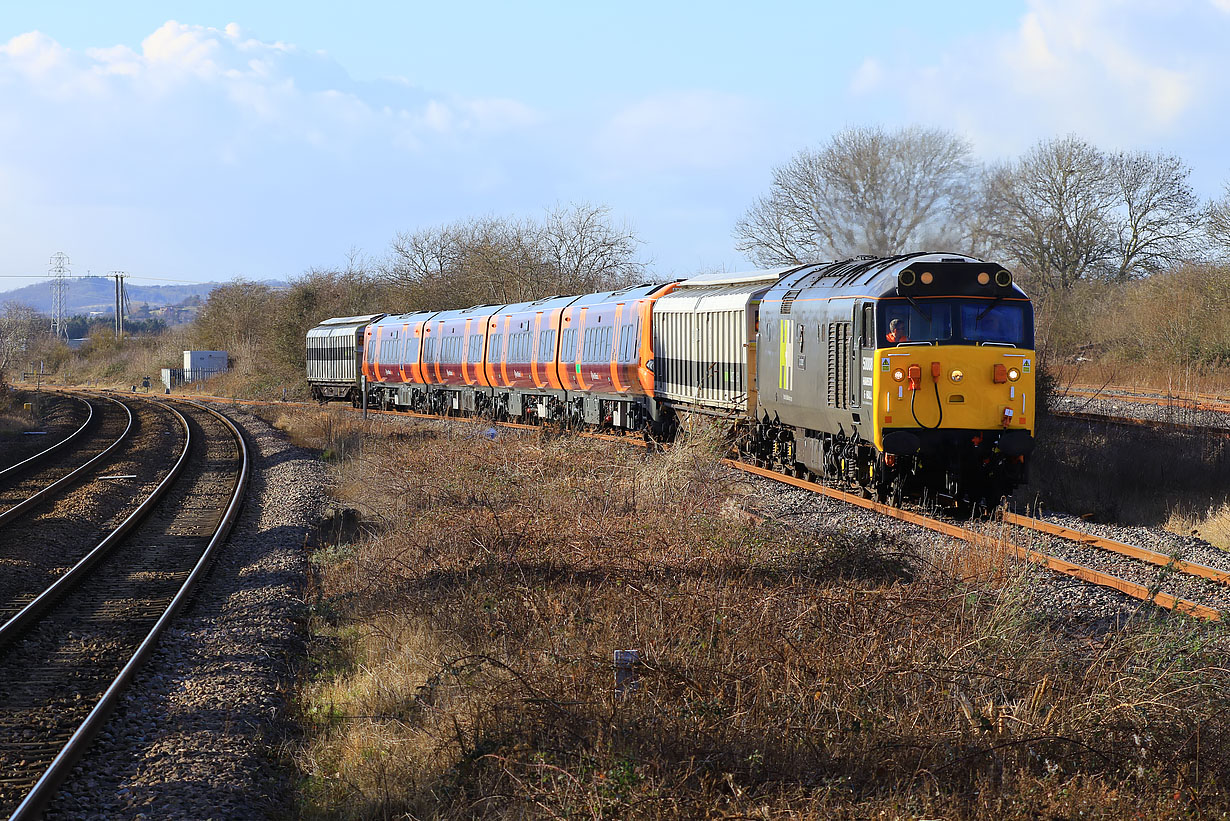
[48,409,327,819]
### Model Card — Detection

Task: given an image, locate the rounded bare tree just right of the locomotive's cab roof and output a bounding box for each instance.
[985,137,1119,294]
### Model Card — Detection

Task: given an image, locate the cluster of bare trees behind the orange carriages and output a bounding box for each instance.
[383,203,646,310]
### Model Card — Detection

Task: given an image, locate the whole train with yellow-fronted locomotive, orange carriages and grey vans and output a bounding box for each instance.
[308,254,1037,503]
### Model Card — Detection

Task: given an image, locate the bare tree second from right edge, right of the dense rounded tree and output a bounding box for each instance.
[1108,151,1200,282]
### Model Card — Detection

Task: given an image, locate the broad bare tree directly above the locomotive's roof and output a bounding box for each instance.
[734,127,977,265]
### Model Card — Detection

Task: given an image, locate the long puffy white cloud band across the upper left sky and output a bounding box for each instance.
[0,21,539,155]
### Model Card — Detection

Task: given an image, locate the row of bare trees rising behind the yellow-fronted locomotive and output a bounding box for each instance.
[734,126,1230,290]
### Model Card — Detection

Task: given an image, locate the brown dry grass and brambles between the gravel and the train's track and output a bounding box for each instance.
[279,412,1230,819]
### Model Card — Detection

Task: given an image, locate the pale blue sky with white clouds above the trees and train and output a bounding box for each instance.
[0,0,1230,289]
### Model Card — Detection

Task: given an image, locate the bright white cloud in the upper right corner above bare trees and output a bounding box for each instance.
[851,0,1230,153]
